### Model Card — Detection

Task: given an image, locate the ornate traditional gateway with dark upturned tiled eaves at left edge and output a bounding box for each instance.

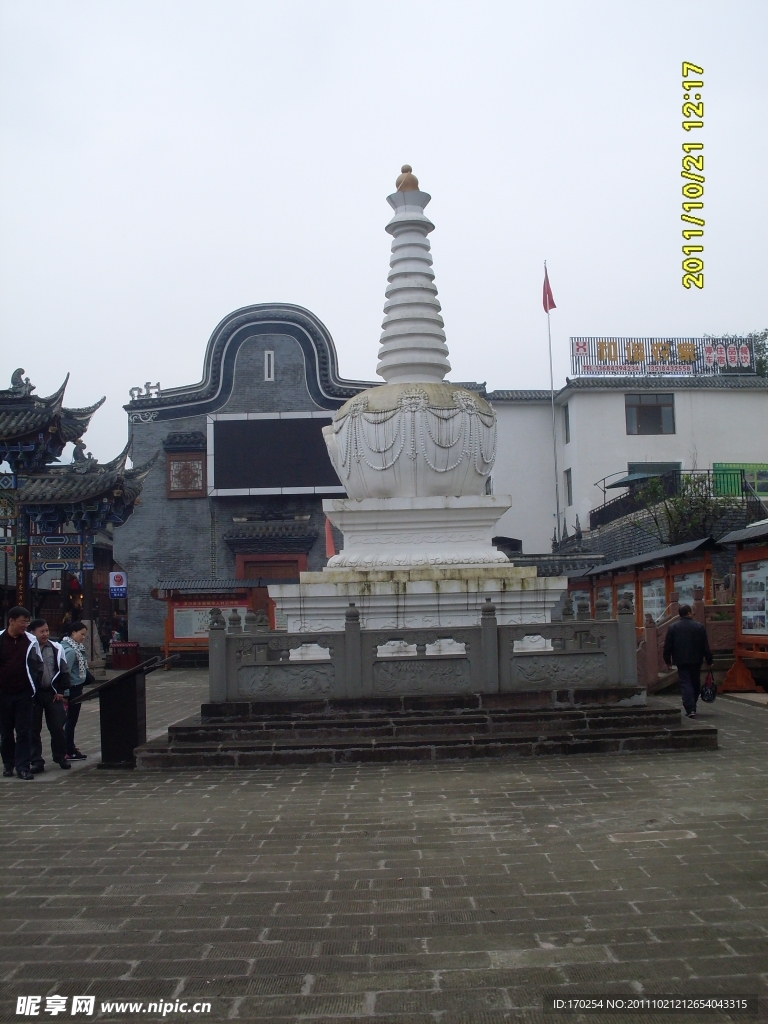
[0,370,148,621]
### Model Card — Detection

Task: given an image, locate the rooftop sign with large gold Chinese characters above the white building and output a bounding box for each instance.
[570,338,756,377]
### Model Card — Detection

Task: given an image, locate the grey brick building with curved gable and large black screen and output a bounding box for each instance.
[115,304,376,649]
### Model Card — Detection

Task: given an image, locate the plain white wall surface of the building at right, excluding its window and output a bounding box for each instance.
[493,382,768,553]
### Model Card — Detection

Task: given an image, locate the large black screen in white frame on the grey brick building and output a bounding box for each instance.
[209,417,344,494]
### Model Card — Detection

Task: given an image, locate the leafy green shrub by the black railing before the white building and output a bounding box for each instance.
[633,473,743,545]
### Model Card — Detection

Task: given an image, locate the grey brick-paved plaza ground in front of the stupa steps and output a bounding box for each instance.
[0,672,768,1024]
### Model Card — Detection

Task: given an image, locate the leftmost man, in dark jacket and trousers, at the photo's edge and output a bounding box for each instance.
[0,606,43,780]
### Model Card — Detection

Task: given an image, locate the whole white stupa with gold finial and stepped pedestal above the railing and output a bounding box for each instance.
[269,165,566,632]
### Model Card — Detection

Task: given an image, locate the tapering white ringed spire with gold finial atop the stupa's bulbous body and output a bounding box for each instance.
[376,164,451,384]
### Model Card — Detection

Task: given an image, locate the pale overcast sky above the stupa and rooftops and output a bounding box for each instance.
[0,0,768,460]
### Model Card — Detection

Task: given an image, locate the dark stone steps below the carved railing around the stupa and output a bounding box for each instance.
[136,687,718,770]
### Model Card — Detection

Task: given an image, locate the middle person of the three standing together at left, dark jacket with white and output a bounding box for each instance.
[30,618,72,775]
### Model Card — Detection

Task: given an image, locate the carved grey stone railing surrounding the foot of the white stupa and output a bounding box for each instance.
[209,599,637,703]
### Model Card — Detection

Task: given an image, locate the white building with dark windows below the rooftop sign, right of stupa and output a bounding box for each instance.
[487,375,768,553]
